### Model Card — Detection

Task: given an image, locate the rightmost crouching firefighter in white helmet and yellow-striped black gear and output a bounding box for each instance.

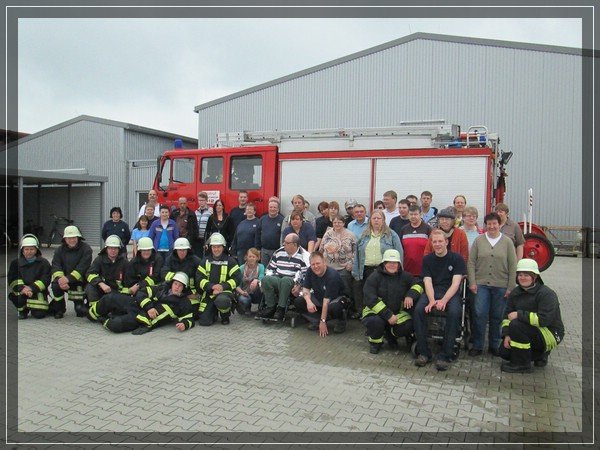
[499,258,565,373]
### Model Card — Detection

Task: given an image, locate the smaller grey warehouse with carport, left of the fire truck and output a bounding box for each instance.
[7,115,198,245]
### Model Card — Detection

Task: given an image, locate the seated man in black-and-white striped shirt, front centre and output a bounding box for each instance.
[256,233,310,320]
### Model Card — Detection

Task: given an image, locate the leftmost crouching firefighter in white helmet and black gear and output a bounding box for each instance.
[8,234,51,319]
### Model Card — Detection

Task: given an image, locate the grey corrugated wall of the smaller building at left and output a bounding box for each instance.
[18,119,197,239]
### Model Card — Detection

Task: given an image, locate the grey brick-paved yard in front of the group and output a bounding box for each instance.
[2,250,586,448]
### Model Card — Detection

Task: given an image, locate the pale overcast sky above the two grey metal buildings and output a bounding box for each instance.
[18,18,582,138]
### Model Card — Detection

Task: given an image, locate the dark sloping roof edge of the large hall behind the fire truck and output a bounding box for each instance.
[194,33,584,113]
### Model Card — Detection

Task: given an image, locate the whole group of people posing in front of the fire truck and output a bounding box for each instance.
[9,191,564,372]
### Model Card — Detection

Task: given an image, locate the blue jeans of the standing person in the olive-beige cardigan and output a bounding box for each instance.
[472,284,506,350]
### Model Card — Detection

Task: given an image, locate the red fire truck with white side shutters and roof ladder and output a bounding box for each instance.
[154,121,553,268]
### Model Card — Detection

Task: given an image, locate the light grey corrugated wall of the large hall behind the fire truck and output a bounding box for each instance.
[198,39,582,229]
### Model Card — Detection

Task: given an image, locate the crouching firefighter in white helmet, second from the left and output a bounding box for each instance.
[50,225,92,319]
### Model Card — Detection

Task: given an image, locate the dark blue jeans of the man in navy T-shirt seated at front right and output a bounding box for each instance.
[413,293,462,361]
